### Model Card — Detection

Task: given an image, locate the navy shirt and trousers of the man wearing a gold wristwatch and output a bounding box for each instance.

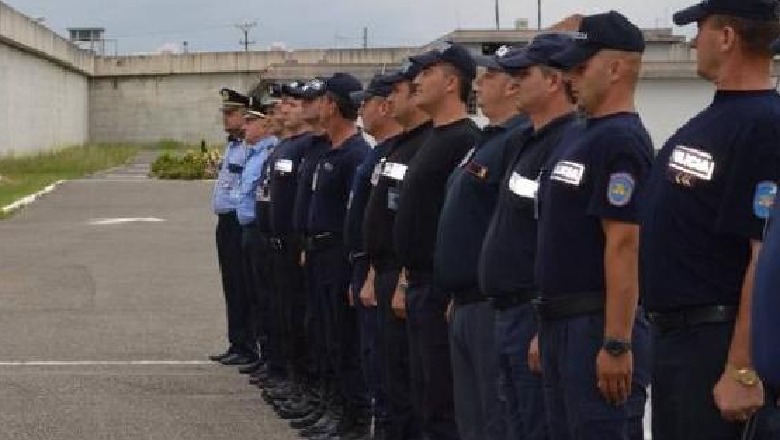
[640,90,780,440]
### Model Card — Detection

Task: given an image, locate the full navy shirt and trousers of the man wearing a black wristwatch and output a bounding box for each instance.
[536,113,652,440]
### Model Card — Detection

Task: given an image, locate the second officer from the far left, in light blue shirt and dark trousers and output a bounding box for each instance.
[234,96,278,373]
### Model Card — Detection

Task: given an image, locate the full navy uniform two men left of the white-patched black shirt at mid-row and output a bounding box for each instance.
[306,133,370,409]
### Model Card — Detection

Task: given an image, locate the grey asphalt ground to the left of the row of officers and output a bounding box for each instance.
[0,155,296,440]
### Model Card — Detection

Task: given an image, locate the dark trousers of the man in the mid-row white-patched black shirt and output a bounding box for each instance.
[374,269,421,440]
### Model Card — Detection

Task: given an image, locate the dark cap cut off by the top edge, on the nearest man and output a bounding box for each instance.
[673,0,780,26]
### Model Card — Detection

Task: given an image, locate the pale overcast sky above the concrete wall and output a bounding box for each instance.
[2,0,693,53]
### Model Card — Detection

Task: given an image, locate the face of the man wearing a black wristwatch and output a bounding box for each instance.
[568,52,612,114]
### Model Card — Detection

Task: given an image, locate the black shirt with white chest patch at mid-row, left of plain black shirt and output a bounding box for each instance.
[363,122,433,269]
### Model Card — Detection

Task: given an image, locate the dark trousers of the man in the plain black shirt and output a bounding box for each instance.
[406,280,459,440]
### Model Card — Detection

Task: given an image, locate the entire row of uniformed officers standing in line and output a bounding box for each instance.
[206,0,780,440]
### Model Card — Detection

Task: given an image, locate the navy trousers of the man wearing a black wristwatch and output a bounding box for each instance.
[539,311,652,440]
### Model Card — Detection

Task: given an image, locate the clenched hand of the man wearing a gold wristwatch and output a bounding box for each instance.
[712,373,764,422]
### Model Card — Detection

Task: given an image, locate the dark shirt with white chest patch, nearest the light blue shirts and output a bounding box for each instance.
[269,133,312,236]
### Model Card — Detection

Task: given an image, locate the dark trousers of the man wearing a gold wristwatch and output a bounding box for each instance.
[651,322,780,440]
